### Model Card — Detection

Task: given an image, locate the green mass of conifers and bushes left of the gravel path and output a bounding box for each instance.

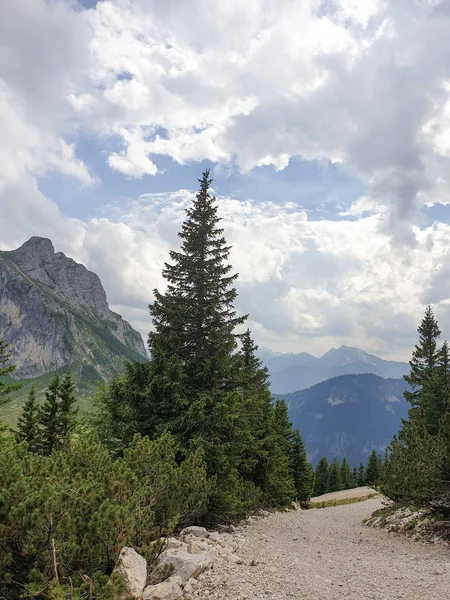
[0,171,314,600]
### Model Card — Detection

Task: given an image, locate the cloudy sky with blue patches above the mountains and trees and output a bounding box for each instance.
[0,0,450,360]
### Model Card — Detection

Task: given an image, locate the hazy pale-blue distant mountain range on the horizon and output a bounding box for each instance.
[264,346,409,394]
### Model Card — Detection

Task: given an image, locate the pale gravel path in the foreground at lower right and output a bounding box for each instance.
[195,499,450,600]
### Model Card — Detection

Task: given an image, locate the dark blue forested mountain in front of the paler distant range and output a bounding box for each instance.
[280,374,409,466]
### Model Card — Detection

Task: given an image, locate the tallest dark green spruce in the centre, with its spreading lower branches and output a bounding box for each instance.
[97,171,296,523]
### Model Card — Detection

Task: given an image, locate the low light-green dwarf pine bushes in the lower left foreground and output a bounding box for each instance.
[0,434,210,598]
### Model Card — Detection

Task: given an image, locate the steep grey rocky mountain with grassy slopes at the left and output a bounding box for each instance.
[0,237,147,382]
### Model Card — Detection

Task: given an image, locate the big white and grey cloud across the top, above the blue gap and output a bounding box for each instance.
[45,0,450,245]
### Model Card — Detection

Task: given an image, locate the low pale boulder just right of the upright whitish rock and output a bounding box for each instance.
[150,550,214,585]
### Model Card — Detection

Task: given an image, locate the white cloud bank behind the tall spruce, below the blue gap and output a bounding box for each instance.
[73,190,450,359]
